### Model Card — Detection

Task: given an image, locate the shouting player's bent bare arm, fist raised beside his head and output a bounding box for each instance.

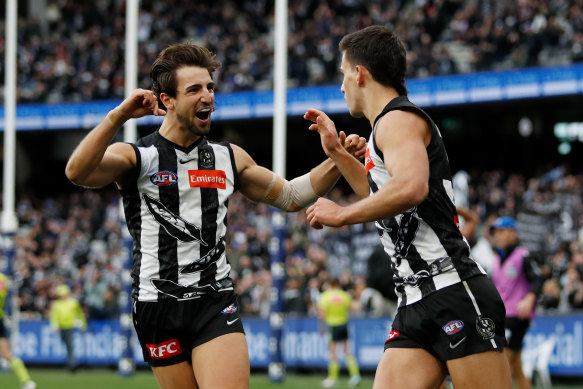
[65,89,166,188]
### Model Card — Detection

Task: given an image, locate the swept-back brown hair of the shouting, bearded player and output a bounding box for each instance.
[150,43,221,108]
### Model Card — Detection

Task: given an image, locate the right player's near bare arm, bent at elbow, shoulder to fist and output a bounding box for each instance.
[306,111,431,228]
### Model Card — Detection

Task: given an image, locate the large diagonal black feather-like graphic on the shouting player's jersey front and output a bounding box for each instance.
[144,194,207,246]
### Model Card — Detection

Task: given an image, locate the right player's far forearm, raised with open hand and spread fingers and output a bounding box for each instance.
[304,108,369,198]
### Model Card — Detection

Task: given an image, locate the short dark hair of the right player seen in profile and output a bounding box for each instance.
[338,26,407,96]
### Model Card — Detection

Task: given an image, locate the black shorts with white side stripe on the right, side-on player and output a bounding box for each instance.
[385,276,506,362]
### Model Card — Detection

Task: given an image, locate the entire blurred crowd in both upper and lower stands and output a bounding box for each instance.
[0,0,583,319]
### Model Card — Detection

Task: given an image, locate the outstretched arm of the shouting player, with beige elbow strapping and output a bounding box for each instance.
[231,135,366,212]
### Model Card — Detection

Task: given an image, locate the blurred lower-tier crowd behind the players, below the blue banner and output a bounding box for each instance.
[0,167,583,319]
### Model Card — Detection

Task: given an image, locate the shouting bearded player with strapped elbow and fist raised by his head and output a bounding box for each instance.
[66,44,366,389]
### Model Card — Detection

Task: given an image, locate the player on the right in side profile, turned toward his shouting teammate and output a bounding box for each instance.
[305,26,511,389]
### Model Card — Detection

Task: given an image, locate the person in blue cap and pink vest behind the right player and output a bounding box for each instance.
[490,216,543,389]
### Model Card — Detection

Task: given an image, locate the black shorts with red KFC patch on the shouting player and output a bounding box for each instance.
[134,291,245,366]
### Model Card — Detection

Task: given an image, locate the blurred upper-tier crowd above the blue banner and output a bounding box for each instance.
[0,0,583,102]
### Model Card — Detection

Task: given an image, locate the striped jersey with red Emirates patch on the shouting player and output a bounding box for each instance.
[122,131,239,301]
